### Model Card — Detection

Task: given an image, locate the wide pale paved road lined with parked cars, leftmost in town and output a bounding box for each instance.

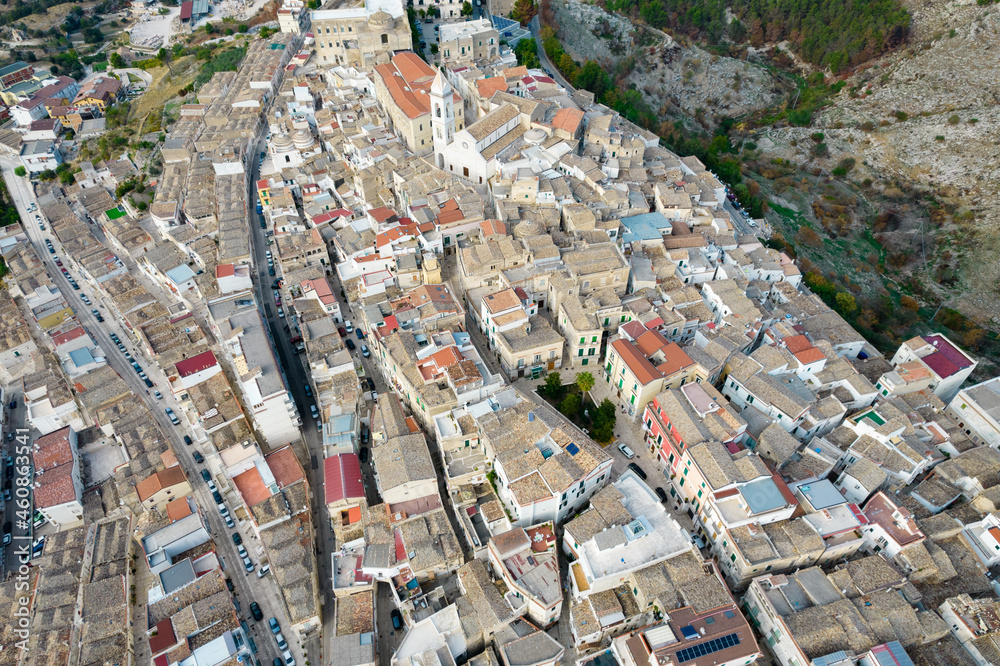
[0,158,294,664]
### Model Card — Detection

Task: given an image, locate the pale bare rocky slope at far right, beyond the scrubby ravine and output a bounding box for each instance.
[758,0,1000,327]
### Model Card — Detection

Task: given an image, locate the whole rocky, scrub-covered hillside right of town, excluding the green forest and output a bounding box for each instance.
[542,0,1000,373]
